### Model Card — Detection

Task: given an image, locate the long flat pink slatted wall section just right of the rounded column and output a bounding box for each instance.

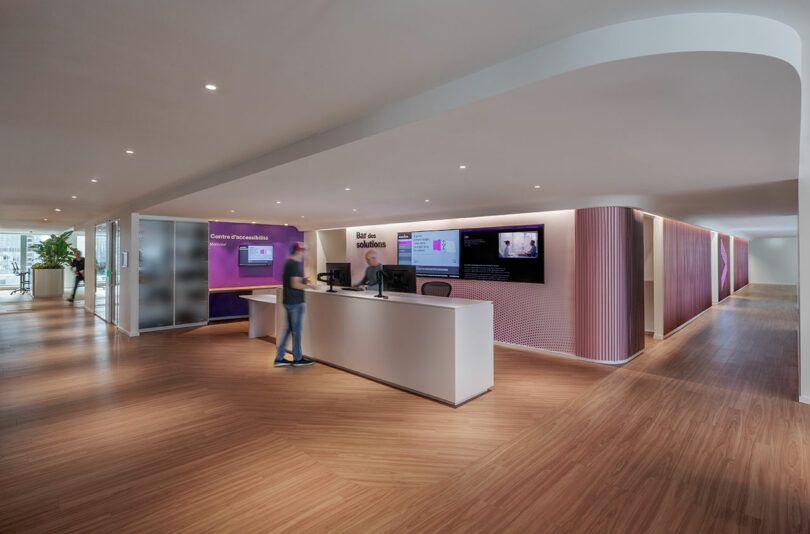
[663,219,719,335]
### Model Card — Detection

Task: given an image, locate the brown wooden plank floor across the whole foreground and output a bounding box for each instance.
[0,286,810,533]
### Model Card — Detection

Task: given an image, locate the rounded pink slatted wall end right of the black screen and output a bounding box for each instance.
[575,207,644,362]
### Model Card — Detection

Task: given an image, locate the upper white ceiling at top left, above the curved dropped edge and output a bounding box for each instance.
[0,0,810,238]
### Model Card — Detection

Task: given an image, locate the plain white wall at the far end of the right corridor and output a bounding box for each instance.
[748,237,799,285]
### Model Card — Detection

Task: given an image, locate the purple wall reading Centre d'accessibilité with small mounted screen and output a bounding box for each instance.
[208,221,304,288]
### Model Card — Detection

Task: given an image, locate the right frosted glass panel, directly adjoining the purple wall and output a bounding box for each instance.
[174,221,208,325]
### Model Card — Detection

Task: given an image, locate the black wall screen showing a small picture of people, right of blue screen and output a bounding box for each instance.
[461,225,545,284]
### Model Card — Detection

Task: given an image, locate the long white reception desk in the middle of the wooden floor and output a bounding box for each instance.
[276,289,494,406]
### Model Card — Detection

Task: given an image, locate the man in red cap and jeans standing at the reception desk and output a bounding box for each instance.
[274,242,315,367]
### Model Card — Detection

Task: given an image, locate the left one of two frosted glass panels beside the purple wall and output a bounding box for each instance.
[138,219,174,330]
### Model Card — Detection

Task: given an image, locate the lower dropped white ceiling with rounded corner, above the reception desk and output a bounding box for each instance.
[145,53,800,239]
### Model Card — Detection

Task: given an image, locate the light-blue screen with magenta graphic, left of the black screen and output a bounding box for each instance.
[397,230,460,278]
